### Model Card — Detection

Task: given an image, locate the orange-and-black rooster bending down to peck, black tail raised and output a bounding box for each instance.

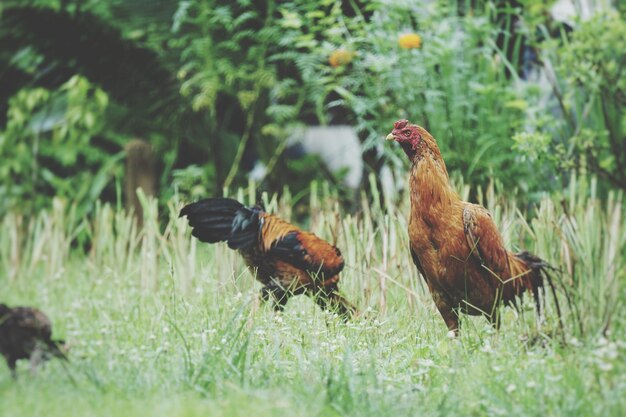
[180,198,356,318]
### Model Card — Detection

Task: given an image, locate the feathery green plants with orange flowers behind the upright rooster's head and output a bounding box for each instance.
[270,1,536,188]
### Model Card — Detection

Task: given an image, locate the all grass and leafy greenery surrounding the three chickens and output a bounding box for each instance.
[0,0,626,417]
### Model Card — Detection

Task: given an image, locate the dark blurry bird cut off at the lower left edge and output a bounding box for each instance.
[0,304,67,378]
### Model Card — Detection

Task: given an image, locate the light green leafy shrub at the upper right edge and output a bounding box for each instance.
[515,12,626,189]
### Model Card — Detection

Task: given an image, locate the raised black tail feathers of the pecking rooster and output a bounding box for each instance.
[180,198,260,249]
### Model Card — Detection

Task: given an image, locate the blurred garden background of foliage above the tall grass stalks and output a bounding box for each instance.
[0,0,626,218]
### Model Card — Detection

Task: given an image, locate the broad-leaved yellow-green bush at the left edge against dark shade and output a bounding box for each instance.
[0,76,122,216]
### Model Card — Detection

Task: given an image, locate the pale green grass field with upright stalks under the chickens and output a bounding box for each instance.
[0,182,626,417]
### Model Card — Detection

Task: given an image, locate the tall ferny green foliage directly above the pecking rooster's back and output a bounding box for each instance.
[172,0,284,190]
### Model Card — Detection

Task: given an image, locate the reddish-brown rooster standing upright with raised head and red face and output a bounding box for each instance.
[387,120,548,333]
